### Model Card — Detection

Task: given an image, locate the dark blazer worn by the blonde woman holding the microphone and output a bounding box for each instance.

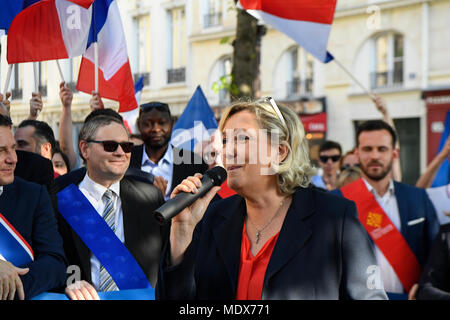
[157,188,386,300]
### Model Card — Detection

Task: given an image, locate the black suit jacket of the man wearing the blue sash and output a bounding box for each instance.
[56,168,169,287]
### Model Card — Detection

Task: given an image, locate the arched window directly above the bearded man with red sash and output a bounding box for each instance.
[370,33,404,89]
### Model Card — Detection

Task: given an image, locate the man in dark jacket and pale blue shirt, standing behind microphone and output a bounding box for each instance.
[130,102,208,200]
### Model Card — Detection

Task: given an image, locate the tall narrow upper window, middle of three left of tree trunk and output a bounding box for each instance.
[167,7,187,83]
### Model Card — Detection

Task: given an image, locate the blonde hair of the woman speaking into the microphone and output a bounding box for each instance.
[219,100,314,194]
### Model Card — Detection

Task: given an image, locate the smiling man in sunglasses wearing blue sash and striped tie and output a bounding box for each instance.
[58,115,168,300]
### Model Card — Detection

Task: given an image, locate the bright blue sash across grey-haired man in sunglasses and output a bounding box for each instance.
[58,184,152,290]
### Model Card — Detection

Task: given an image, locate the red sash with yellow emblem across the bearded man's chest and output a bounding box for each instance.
[340,179,421,292]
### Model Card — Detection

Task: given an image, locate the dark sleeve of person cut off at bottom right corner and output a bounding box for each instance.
[416,224,450,300]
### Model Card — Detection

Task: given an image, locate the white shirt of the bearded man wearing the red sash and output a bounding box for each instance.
[363,178,404,293]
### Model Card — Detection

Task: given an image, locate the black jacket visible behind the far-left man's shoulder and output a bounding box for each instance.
[14,150,58,215]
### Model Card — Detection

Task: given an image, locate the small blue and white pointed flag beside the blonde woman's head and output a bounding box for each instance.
[171,86,217,151]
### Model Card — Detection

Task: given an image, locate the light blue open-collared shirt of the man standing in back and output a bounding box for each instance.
[141,143,173,200]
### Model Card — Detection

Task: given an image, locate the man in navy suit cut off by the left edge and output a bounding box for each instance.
[0,115,66,300]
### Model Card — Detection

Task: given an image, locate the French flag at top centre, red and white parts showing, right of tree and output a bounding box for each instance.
[238,0,337,63]
